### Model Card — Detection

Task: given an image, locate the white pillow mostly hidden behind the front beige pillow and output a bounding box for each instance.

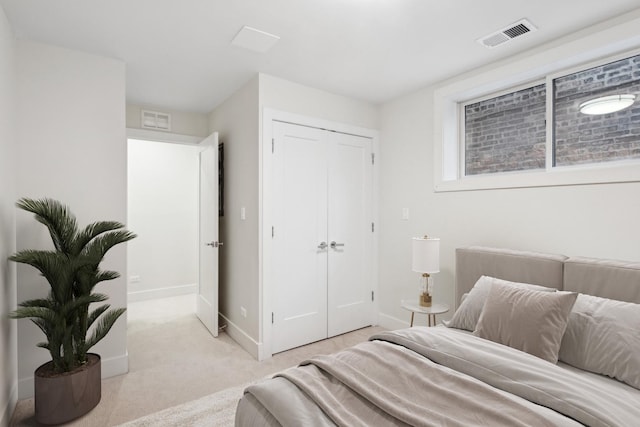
[442,276,556,332]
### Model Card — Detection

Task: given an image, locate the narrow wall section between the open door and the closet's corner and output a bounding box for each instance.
[209,76,260,348]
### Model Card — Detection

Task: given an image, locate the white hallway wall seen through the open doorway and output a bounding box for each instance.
[127,139,200,302]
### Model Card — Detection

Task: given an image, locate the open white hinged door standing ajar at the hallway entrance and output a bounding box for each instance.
[196,132,221,337]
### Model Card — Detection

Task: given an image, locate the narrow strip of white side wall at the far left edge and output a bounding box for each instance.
[0,7,18,426]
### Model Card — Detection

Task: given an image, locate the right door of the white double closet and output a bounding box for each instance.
[327,132,373,337]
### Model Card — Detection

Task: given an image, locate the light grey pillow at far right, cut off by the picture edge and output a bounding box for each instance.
[559,294,640,389]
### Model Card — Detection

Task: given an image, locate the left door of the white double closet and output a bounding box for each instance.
[271,121,328,353]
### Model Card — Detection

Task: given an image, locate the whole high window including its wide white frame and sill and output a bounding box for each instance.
[431,17,640,192]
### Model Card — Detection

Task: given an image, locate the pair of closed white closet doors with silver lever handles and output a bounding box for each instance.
[271,121,373,353]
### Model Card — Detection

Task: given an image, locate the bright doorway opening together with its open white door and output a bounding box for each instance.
[127,133,222,337]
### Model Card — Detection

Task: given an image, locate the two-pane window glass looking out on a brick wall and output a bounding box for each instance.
[459,55,640,176]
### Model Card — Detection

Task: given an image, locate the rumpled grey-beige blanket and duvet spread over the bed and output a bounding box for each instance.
[241,328,640,426]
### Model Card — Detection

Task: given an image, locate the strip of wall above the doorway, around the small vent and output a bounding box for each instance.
[127,104,209,138]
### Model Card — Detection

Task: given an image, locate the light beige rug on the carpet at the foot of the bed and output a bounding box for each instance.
[120,383,251,427]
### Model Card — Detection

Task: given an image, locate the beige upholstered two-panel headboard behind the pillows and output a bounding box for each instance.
[456,246,640,306]
